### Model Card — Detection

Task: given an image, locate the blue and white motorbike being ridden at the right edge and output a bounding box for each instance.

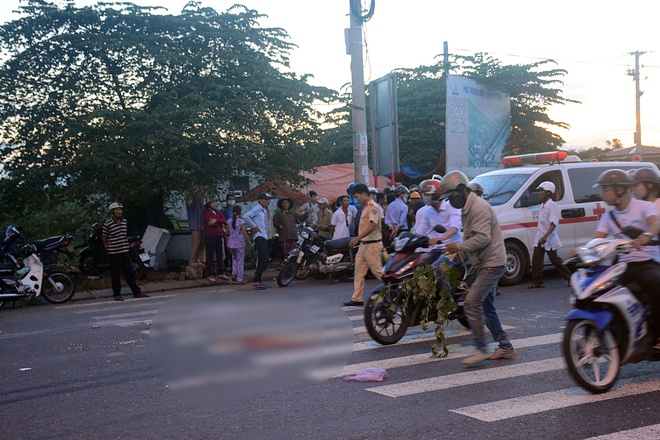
[563,235,660,393]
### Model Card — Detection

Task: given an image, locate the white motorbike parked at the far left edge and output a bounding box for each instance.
[0,226,76,308]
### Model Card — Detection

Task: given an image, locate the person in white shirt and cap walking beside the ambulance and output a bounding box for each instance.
[529,181,571,289]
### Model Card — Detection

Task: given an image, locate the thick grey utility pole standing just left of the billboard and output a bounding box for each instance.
[347,0,369,185]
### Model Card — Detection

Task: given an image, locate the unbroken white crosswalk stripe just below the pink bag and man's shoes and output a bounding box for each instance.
[367,358,566,397]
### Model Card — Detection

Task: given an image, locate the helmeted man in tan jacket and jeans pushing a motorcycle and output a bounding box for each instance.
[440,171,516,365]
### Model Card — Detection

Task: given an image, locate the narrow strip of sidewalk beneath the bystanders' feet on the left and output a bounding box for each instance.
[79,267,279,302]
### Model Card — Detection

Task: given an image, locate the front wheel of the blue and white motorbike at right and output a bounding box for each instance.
[563,319,621,394]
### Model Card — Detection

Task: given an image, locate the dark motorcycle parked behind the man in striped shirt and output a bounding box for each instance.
[78,223,150,280]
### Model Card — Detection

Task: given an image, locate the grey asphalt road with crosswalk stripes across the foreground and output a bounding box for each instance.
[0,272,660,440]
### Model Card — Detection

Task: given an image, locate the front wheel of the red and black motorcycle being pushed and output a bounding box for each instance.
[364,292,408,345]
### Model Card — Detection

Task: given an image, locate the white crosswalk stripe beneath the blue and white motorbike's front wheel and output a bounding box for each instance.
[450,374,660,422]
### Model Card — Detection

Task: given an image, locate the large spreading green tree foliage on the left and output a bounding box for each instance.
[0,0,333,230]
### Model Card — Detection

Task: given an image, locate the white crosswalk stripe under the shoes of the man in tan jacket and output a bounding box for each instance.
[335,333,562,377]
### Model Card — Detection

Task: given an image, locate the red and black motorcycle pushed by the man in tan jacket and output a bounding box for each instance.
[364,226,475,345]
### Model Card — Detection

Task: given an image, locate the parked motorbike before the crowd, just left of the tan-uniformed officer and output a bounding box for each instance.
[277,226,355,287]
